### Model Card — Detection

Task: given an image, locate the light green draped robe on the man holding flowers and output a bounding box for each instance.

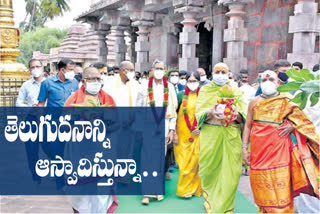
[196,82,246,213]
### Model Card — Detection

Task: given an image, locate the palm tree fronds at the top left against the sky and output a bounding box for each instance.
[20,0,70,31]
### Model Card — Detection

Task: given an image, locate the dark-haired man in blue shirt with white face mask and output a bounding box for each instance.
[38,59,79,107]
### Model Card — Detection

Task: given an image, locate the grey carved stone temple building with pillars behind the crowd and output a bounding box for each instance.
[34,0,320,80]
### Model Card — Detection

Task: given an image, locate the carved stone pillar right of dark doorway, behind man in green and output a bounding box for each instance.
[218,0,254,73]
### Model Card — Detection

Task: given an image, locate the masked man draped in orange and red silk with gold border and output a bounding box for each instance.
[242,71,319,213]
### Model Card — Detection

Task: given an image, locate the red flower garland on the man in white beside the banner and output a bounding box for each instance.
[148,77,169,124]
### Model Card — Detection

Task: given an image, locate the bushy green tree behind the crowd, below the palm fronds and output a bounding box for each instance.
[17,28,67,66]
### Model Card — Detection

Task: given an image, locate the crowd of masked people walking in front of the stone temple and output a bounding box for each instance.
[17,59,320,213]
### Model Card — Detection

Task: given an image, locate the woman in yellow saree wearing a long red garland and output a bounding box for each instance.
[174,72,202,198]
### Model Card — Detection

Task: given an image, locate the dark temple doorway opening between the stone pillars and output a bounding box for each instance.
[196,22,213,76]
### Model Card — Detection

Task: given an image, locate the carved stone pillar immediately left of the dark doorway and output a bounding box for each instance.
[173,0,204,71]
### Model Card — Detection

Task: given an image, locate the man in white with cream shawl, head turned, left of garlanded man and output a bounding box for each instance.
[103,61,144,107]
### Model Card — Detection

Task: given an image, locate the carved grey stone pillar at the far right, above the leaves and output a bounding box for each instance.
[288,0,320,69]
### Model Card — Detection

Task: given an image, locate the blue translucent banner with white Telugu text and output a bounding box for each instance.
[0,107,165,195]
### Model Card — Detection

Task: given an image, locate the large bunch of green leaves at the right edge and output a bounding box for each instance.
[278,69,320,110]
